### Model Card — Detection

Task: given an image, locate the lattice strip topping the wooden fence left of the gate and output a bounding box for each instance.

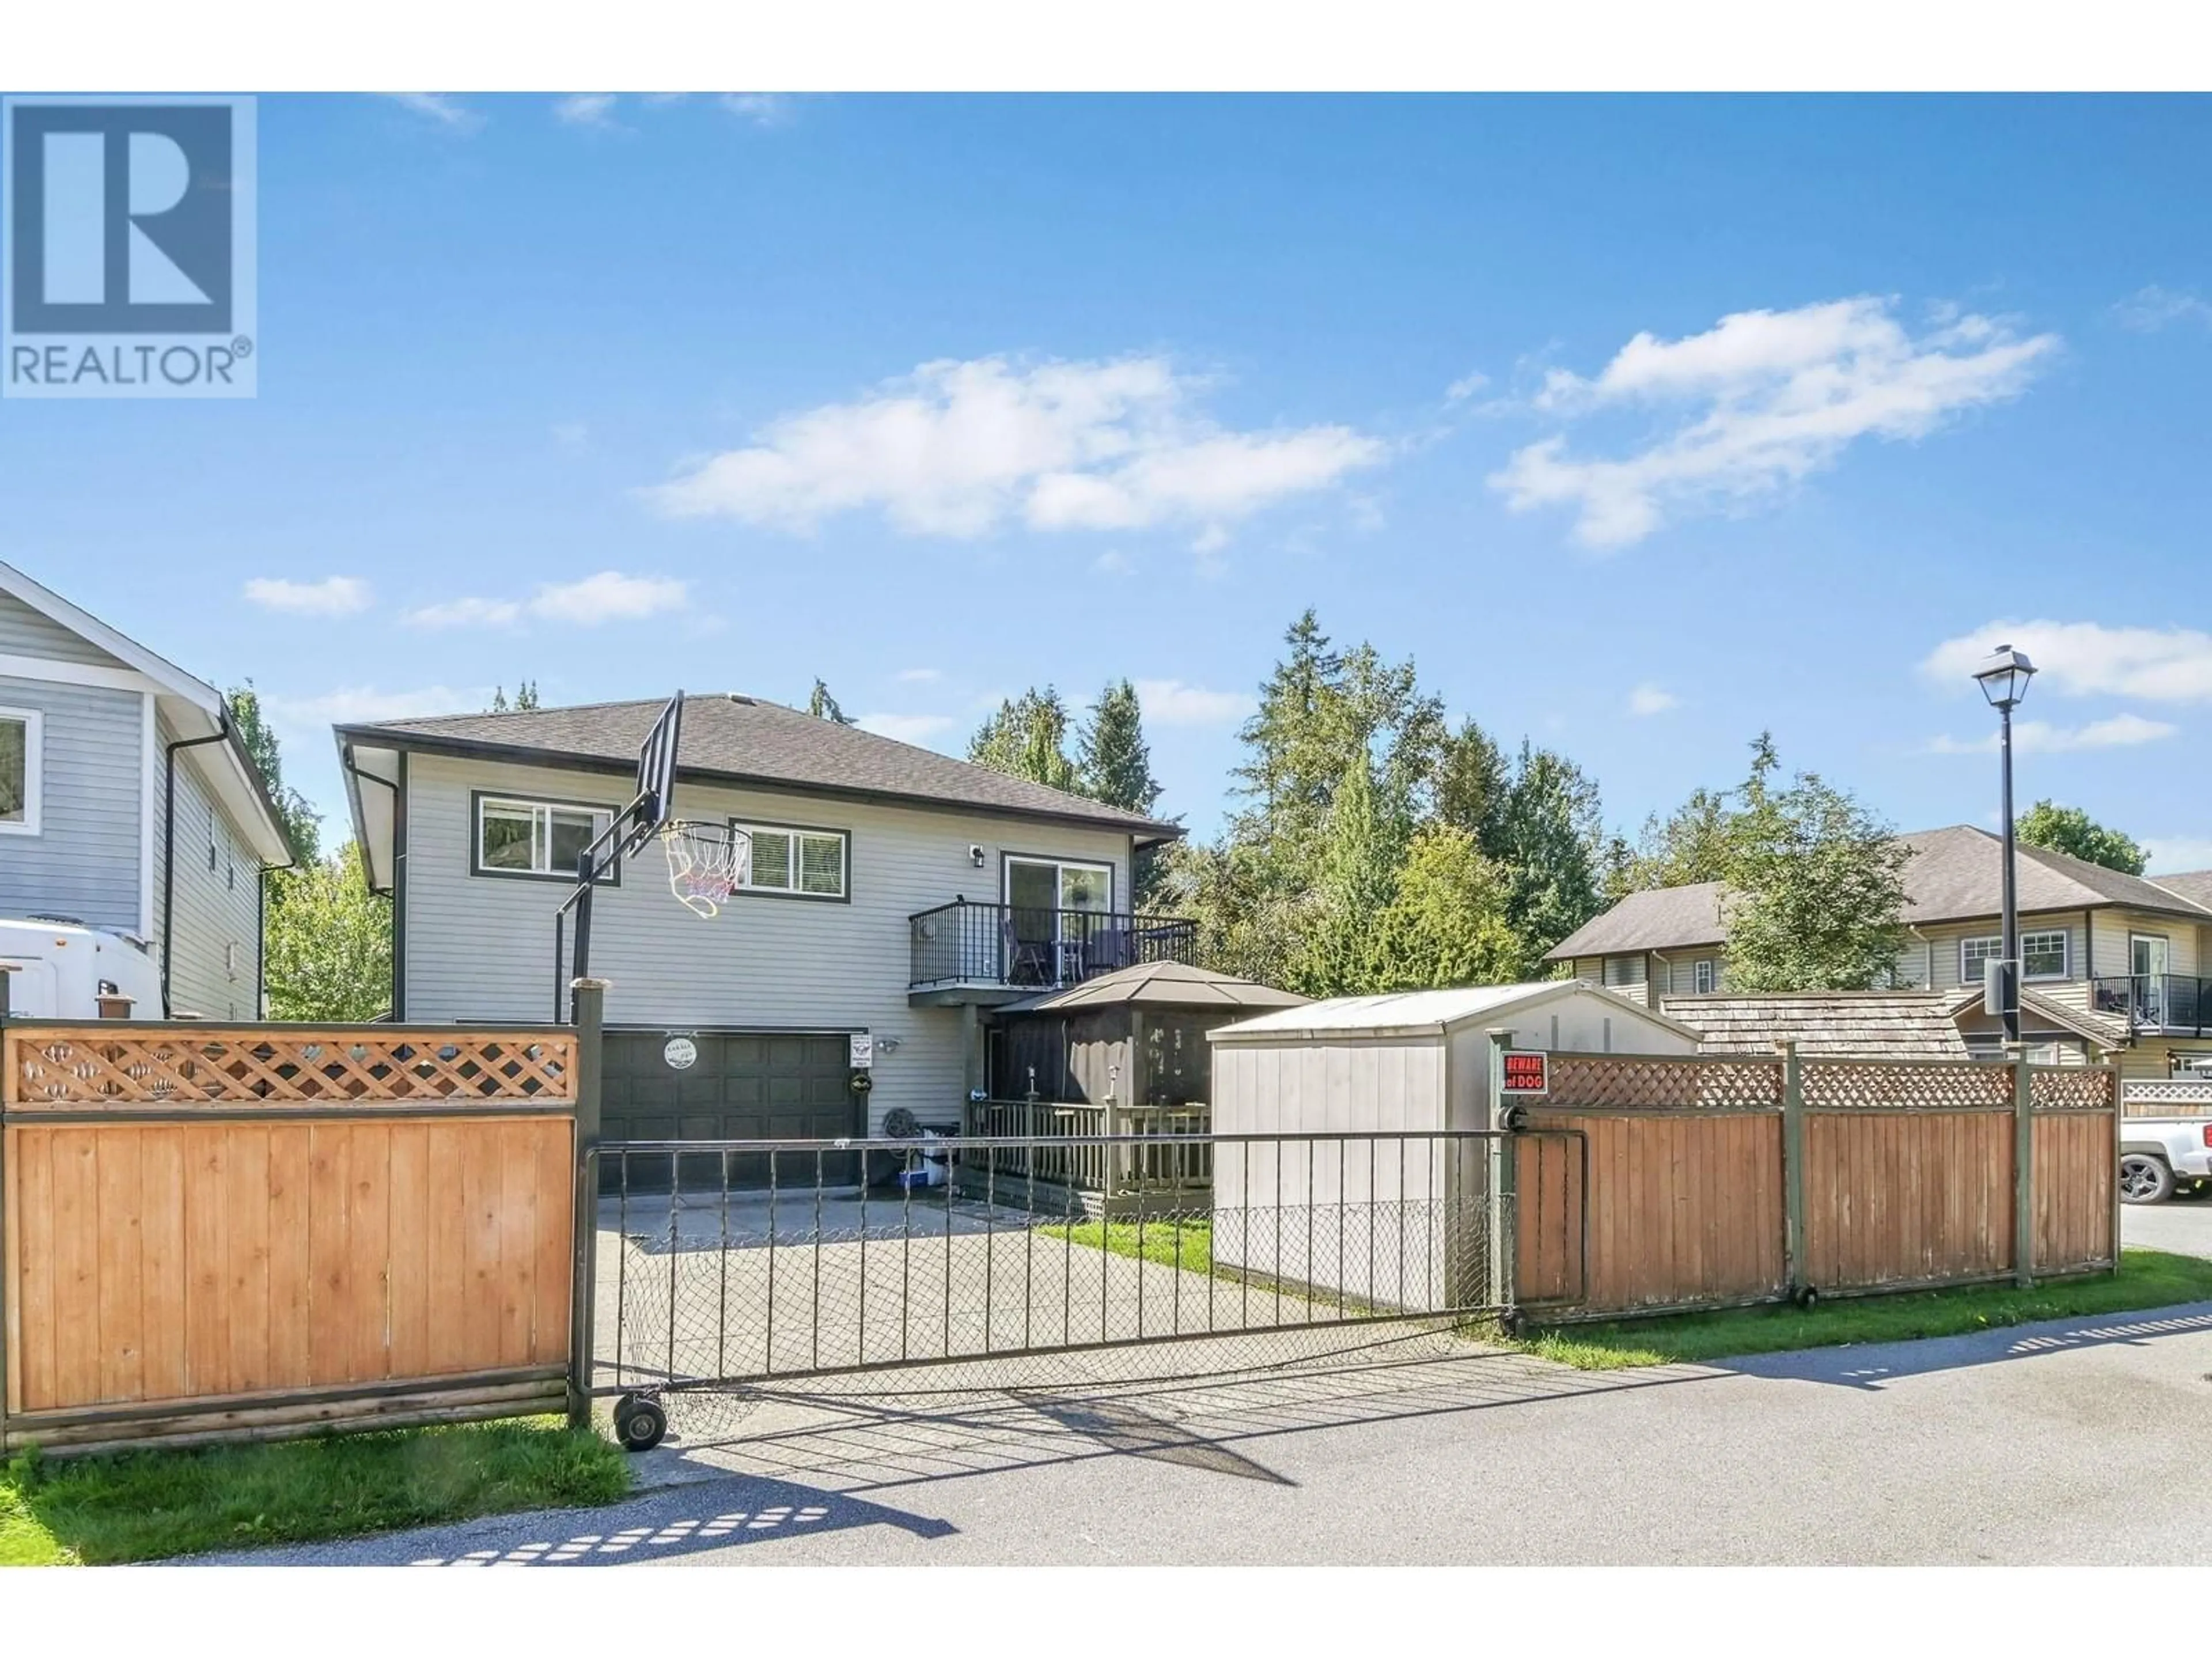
[7,1027,575,1111]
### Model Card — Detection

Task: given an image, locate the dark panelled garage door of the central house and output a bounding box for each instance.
[600,1031,865,1188]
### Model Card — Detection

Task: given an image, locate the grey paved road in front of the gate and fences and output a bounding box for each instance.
[207,1300,2212,1566]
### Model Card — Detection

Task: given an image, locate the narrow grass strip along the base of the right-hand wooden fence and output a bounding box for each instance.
[1482,1250,2212,1372]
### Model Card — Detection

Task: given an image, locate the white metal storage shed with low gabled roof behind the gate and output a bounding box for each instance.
[1208,980,1699,1307]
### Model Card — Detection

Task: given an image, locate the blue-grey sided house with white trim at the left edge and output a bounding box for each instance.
[0,564,292,1020]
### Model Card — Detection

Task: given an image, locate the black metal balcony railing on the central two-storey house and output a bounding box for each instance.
[907,898,1199,991]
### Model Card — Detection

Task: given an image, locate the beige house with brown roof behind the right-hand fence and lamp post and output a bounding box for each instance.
[1546,825,2212,1077]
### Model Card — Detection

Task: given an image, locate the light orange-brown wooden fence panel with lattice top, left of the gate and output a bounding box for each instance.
[0,1022,577,1446]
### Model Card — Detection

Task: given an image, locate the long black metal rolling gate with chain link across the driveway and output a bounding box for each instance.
[584,1130,1584,1449]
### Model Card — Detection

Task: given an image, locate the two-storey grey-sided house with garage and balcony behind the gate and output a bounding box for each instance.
[336,695,1196,1139]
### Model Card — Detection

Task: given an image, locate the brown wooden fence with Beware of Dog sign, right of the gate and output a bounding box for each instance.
[1513,1051,2119,1316]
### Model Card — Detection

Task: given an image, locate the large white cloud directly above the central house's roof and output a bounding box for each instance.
[646,356,1385,537]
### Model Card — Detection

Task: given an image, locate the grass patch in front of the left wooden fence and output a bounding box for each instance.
[0,1418,630,1566]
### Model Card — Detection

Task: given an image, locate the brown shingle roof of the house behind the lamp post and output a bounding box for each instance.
[1544,823,2212,962]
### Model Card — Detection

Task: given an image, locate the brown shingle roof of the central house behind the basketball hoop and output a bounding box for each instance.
[339,692,1181,838]
